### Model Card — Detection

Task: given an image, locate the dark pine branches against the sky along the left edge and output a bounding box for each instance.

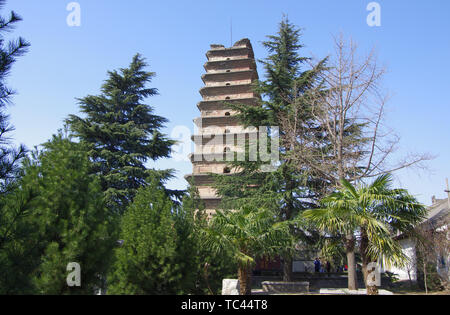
[0,0,30,195]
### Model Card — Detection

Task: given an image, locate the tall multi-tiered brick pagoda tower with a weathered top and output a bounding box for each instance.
[186,39,260,216]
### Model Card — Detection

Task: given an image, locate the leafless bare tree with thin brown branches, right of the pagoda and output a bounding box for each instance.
[279,34,433,289]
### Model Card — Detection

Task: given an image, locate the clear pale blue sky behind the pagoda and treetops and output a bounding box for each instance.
[1,0,450,204]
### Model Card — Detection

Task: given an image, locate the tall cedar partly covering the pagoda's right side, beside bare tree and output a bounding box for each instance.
[216,17,325,281]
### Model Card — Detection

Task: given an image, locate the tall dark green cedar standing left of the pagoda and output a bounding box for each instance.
[66,54,180,214]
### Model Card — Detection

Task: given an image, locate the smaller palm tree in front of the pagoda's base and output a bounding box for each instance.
[203,206,293,295]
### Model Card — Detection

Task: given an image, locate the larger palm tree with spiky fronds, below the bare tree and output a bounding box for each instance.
[301,174,426,295]
